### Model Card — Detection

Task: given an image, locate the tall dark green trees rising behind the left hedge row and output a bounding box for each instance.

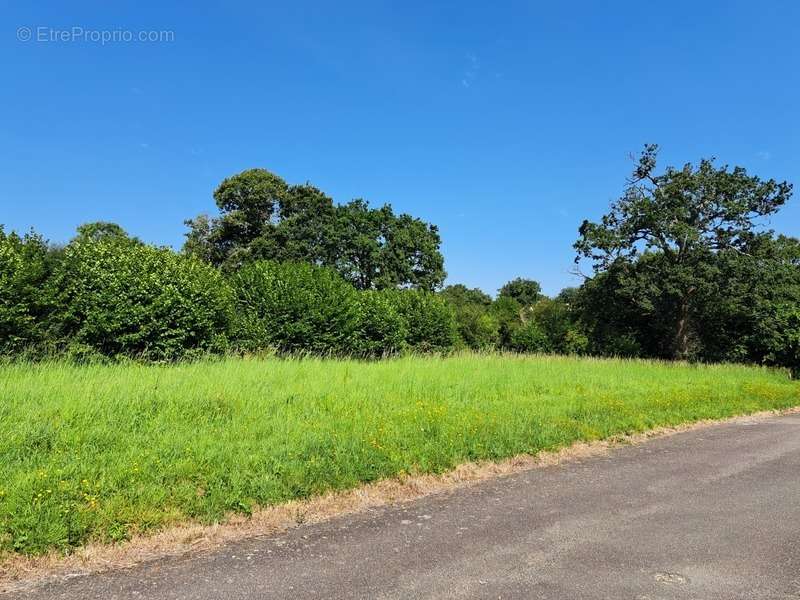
[184,169,445,290]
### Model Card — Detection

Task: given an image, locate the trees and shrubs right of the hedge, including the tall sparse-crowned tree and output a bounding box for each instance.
[443,145,800,373]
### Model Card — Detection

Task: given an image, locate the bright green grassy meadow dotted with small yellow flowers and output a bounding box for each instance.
[0,355,800,554]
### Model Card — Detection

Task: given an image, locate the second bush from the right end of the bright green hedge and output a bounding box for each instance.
[350,290,408,356]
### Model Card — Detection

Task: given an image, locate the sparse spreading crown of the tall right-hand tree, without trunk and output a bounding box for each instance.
[575,144,792,270]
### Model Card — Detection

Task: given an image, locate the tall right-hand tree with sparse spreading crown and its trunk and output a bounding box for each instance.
[574,145,792,358]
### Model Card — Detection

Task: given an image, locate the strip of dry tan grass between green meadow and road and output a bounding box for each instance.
[0,407,800,593]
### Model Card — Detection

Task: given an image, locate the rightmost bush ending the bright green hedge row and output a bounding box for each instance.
[383,289,458,352]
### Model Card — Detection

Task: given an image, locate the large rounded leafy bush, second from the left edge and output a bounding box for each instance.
[47,239,232,360]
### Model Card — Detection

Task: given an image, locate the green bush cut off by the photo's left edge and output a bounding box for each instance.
[0,227,48,354]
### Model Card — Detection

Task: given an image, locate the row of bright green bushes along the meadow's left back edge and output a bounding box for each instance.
[0,224,456,360]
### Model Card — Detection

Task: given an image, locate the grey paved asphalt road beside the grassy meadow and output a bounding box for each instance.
[10,414,800,600]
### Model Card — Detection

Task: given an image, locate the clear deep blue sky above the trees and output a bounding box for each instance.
[0,0,800,293]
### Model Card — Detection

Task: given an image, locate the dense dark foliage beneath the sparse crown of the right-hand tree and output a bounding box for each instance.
[575,234,800,368]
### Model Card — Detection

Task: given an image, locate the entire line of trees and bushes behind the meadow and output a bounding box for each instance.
[0,146,800,372]
